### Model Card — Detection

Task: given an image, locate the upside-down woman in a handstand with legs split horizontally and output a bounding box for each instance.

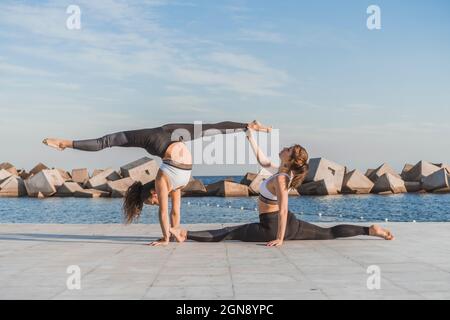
[43,121,270,246]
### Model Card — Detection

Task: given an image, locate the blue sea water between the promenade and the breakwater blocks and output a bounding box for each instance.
[0,177,450,224]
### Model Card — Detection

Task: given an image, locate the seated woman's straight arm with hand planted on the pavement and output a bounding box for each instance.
[267,175,289,247]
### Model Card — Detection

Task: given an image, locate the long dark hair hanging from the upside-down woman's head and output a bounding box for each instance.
[122,181,155,224]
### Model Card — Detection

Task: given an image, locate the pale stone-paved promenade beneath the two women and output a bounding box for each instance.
[0,223,450,299]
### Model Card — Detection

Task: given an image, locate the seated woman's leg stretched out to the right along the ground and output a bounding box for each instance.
[293,221,394,240]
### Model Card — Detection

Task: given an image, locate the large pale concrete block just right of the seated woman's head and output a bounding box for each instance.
[305,158,346,192]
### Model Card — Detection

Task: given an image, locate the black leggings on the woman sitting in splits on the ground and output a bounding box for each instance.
[187,212,369,242]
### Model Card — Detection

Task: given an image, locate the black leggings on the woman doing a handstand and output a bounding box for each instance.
[73,121,247,158]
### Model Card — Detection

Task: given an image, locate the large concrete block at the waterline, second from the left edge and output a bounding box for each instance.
[25,169,64,197]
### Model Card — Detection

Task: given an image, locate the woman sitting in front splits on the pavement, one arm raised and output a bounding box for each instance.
[170,130,394,246]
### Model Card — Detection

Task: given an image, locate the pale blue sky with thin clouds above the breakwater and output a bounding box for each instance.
[0,0,450,175]
